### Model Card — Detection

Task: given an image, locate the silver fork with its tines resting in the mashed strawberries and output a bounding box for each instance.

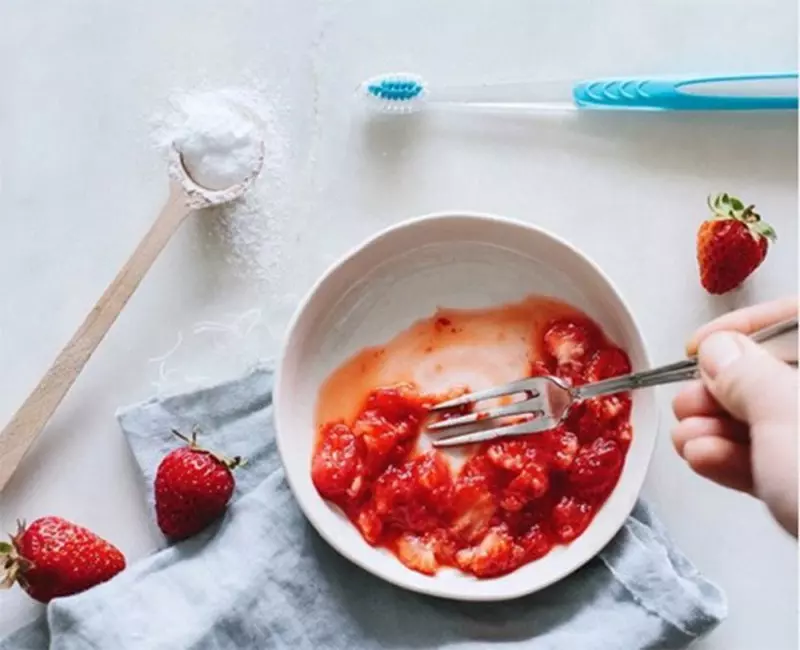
[427,318,798,447]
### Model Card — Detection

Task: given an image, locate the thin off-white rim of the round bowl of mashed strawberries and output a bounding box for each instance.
[272,209,661,602]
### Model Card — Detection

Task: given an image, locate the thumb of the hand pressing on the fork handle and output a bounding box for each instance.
[698,332,797,427]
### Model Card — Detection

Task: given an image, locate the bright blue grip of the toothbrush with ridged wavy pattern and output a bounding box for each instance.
[573,72,797,111]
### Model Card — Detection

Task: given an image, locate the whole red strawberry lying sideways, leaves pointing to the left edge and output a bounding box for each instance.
[0,517,125,603]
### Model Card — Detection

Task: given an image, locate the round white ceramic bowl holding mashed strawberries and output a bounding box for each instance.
[275,213,658,601]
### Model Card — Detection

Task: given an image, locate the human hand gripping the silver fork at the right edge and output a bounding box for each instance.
[672,298,798,536]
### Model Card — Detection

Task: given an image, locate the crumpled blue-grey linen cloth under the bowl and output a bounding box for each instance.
[0,368,726,650]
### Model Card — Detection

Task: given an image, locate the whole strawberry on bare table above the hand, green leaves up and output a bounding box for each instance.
[697,194,775,294]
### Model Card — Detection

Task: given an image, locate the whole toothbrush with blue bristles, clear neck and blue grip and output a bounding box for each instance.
[358,72,798,114]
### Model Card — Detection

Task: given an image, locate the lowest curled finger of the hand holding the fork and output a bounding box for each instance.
[683,437,753,493]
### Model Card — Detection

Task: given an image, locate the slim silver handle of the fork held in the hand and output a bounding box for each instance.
[572,318,798,399]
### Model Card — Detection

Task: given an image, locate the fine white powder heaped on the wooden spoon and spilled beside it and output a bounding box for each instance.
[153,87,288,283]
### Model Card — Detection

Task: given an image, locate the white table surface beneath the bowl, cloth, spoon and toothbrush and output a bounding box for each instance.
[0,0,798,650]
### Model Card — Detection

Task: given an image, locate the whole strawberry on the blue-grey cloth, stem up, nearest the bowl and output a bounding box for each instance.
[155,430,242,540]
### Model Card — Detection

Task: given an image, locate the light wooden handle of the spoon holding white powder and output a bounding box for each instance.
[0,185,190,491]
